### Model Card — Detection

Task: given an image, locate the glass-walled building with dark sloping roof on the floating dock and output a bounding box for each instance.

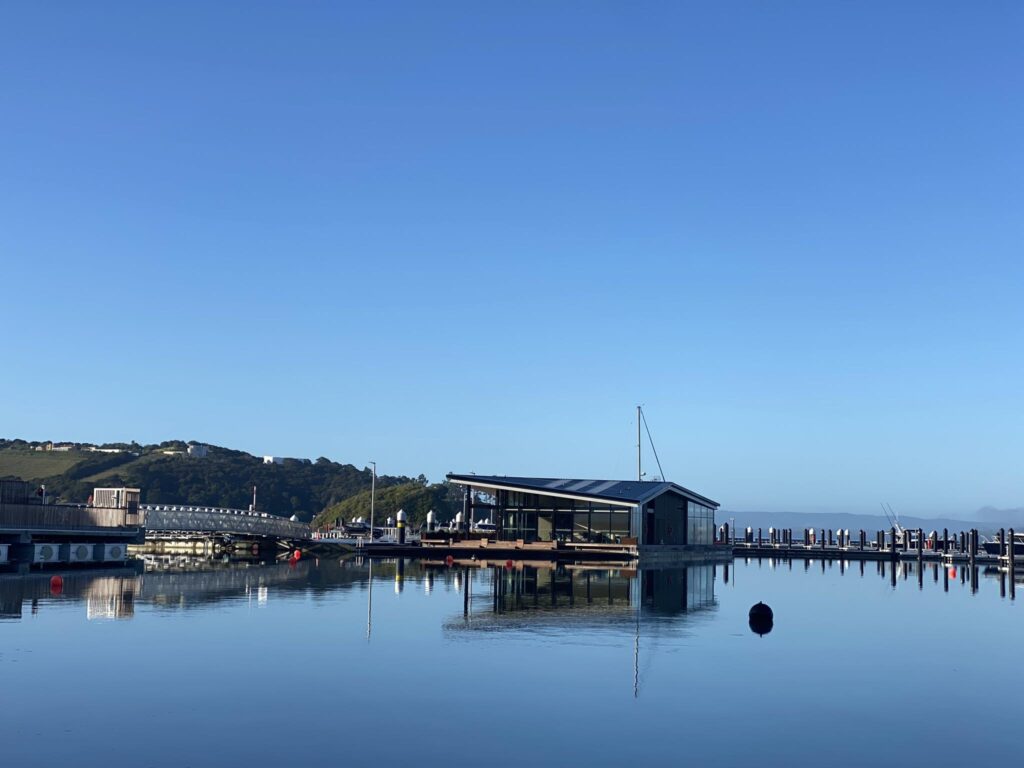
[447,474,719,547]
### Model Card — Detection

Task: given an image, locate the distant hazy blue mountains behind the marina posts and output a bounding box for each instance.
[729,507,1024,539]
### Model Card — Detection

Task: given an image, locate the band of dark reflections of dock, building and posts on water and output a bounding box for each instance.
[0,558,1024,622]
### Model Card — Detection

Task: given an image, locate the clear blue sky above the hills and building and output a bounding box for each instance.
[0,0,1024,514]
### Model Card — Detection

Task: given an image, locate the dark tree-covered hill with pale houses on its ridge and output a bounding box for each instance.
[0,439,426,520]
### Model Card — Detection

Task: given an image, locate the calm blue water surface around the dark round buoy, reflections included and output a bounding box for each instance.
[0,560,1024,766]
